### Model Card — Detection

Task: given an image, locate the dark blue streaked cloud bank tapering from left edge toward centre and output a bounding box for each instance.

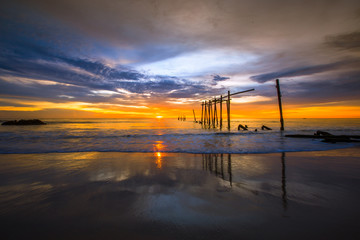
[0,23,217,102]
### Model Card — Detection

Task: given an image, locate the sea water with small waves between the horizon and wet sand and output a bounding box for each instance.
[0,119,360,153]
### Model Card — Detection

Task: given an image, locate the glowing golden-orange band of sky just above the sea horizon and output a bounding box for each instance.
[0,97,360,120]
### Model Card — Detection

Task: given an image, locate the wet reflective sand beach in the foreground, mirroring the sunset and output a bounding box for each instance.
[0,148,360,239]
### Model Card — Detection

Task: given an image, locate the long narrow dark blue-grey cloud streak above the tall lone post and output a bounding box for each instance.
[250,59,360,83]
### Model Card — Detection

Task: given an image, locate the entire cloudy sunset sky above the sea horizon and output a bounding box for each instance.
[0,0,360,119]
